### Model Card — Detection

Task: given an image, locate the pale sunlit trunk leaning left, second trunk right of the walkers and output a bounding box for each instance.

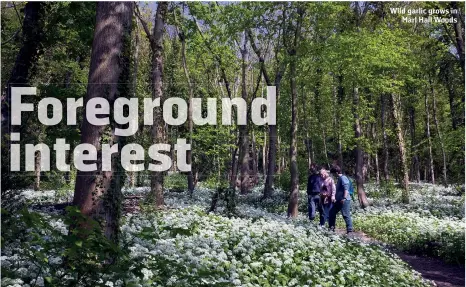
[391,93,409,203]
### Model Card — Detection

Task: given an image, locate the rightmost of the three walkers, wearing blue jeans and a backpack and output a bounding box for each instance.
[329,165,353,233]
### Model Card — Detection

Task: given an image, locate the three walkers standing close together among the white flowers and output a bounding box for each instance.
[307,164,353,233]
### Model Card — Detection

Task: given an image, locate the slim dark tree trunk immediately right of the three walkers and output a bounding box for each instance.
[353,87,369,208]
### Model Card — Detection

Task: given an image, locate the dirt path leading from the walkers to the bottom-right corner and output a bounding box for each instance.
[335,229,465,287]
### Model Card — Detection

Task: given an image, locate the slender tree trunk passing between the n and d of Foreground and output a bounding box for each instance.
[239,33,249,194]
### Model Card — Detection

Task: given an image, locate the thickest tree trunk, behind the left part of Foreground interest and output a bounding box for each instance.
[73,2,133,241]
